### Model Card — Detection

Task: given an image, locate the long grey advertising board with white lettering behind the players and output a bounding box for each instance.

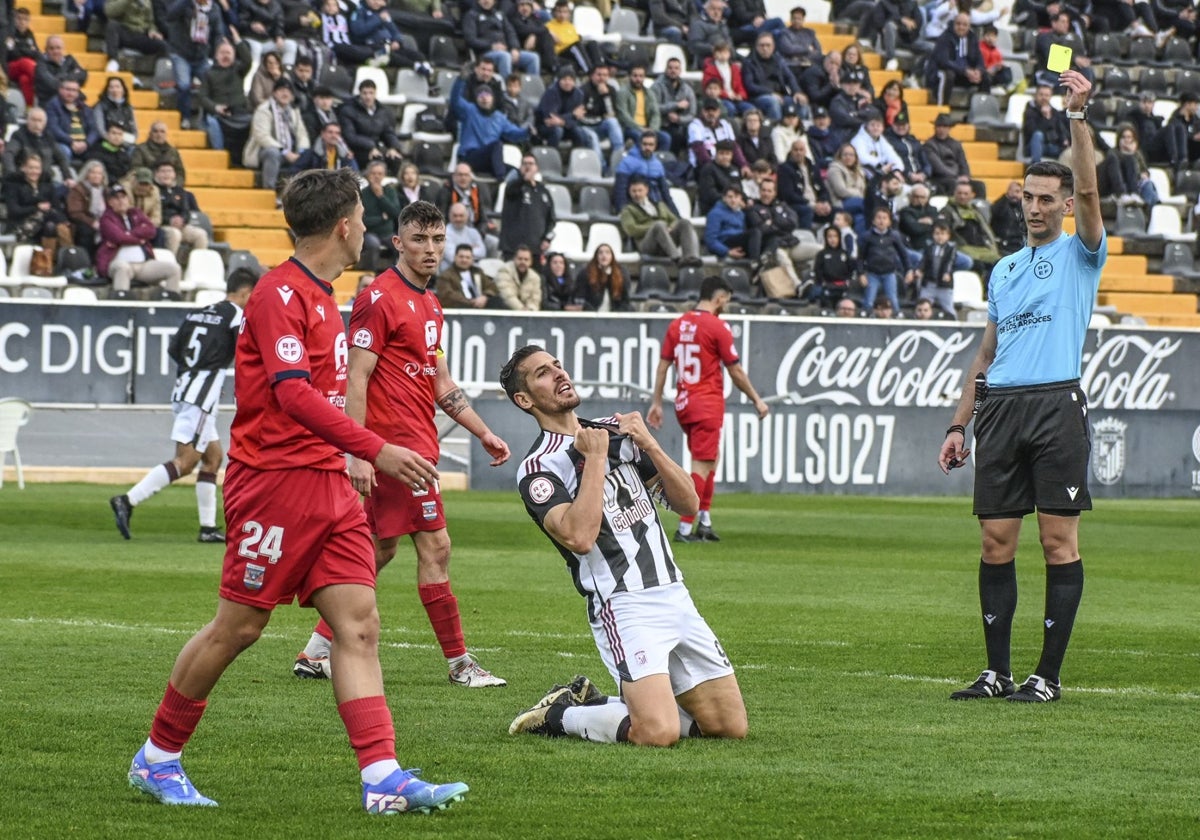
[0,301,1200,497]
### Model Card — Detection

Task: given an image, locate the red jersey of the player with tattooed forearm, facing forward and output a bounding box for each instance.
[350,265,445,463]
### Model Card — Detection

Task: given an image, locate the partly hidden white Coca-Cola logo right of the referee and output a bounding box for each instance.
[1080,332,1182,412]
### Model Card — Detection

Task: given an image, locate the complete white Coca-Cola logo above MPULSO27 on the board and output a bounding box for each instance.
[775,326,976,408]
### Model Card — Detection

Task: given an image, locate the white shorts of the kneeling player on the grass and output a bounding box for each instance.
[592,583,733,696]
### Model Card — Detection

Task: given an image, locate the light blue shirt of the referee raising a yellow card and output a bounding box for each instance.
[988,233,1109,388]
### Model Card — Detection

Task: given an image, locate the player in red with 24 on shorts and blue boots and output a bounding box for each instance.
[128,169,467,814]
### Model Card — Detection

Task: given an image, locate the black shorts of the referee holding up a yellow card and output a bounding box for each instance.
[974,379,1092,518]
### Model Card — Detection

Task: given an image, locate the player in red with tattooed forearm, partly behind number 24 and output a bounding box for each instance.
[293,202,509,688]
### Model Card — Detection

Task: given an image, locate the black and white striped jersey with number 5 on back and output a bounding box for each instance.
[167,300,242,412]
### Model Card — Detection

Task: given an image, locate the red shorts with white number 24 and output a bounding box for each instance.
[221,461,376,610]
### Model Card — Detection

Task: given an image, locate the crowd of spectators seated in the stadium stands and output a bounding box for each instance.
[2,0,1200,317]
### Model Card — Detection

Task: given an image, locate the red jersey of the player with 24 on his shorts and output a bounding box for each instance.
[229,258,349,472]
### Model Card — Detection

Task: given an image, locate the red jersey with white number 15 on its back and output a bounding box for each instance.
[662,310,738,422]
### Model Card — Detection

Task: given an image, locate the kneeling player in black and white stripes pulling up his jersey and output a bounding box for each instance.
[500,346,746,746]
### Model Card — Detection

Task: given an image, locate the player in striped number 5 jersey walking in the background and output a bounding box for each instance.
[108,269,258,542]
